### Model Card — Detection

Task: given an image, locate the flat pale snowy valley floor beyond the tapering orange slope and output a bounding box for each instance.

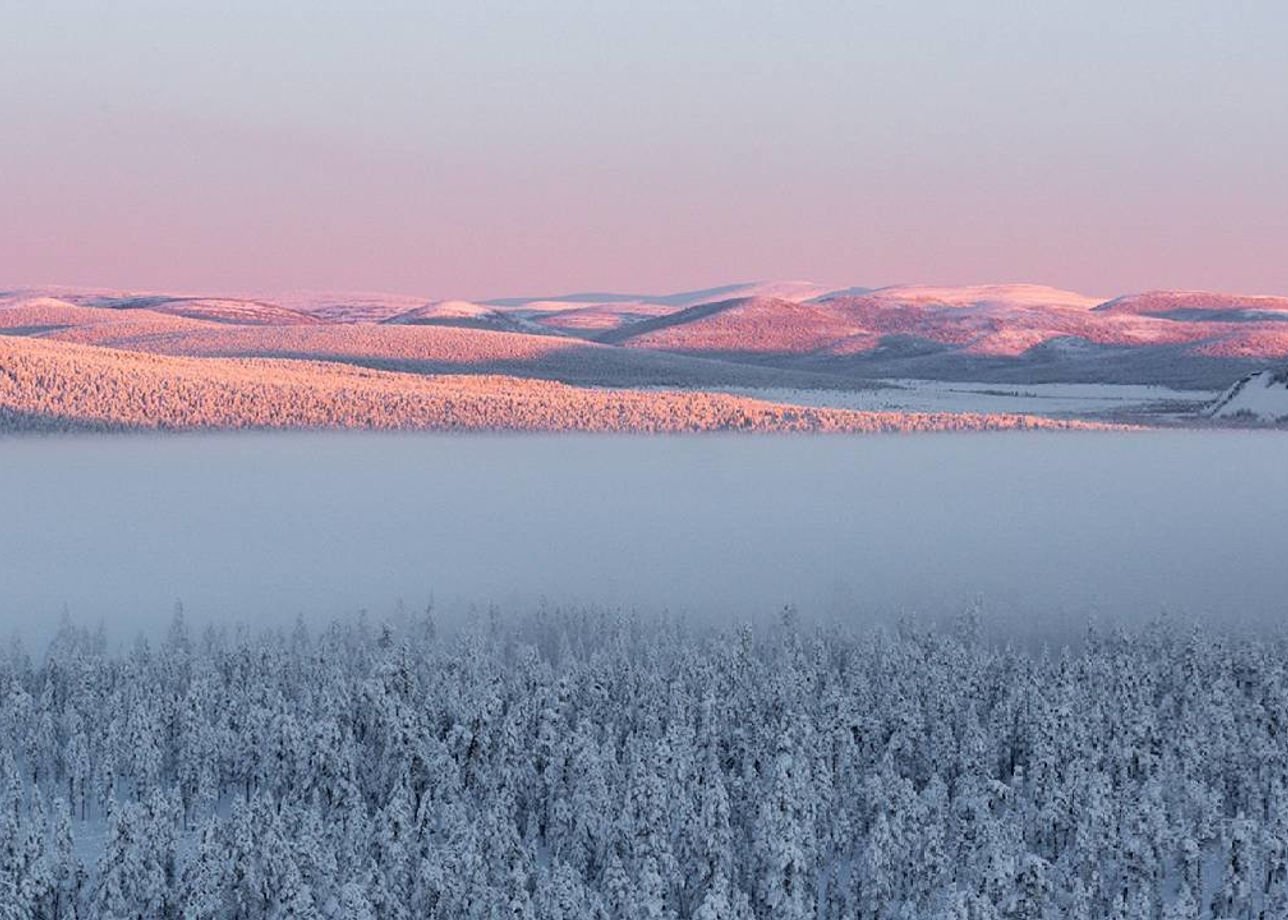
[700,380,1218,417]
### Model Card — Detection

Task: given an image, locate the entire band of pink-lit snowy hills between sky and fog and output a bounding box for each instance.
[0,282,1288,430]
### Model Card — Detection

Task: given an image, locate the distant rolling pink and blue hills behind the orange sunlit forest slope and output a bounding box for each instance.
[0,281,1288,389]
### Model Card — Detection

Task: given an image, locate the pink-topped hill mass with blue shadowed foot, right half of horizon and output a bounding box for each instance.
[596,285,1288,388]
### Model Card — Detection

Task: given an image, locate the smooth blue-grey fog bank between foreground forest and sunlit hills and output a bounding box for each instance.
[0,432,1288,639]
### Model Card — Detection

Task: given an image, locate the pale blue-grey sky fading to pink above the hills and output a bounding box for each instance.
[0,0,1288,298]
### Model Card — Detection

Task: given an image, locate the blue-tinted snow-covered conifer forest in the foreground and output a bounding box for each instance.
[0,609,1288,920]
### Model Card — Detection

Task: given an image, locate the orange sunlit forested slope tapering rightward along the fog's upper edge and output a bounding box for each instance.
[0,336,1081,432]
